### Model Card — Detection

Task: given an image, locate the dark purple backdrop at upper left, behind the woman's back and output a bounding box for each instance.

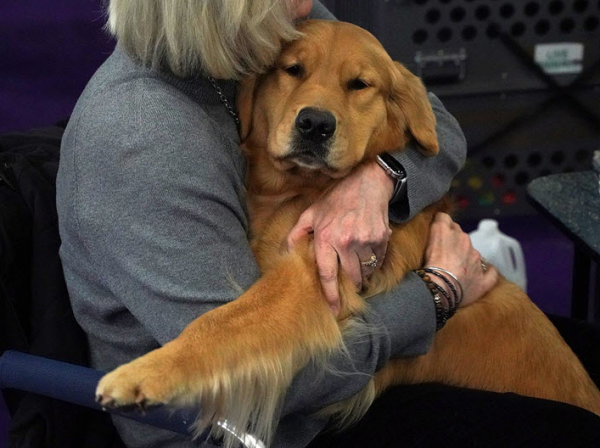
[0,0,114,132]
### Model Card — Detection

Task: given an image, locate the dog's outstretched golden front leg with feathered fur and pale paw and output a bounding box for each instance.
[97,242,356,446]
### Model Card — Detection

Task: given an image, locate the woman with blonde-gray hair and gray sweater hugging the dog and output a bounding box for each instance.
[57,0,600,448]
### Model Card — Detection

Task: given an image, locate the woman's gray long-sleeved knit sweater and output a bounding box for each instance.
[57,3,466,448]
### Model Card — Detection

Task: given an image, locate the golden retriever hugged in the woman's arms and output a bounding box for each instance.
[97,21,600,445]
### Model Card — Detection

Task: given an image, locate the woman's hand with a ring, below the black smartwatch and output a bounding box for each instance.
[287,162,394,316]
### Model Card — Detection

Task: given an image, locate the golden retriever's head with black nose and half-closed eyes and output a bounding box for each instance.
[238,21,438,178]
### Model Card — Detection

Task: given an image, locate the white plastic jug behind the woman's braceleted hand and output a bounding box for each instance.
[469,219,527,291]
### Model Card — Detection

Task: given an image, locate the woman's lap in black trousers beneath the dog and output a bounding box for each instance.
[309,317,600,448]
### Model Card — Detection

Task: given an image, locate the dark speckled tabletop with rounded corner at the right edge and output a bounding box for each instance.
[527,171,600,261]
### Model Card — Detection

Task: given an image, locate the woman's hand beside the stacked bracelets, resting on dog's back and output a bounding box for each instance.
[425,213,498,307]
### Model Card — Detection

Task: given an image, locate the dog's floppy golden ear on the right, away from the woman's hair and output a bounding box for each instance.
[392,62,439,157]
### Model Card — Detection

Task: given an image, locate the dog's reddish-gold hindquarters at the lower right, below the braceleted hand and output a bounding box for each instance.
[376,279,600,415]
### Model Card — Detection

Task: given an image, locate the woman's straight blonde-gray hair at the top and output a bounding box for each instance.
[107,0,300,79]
